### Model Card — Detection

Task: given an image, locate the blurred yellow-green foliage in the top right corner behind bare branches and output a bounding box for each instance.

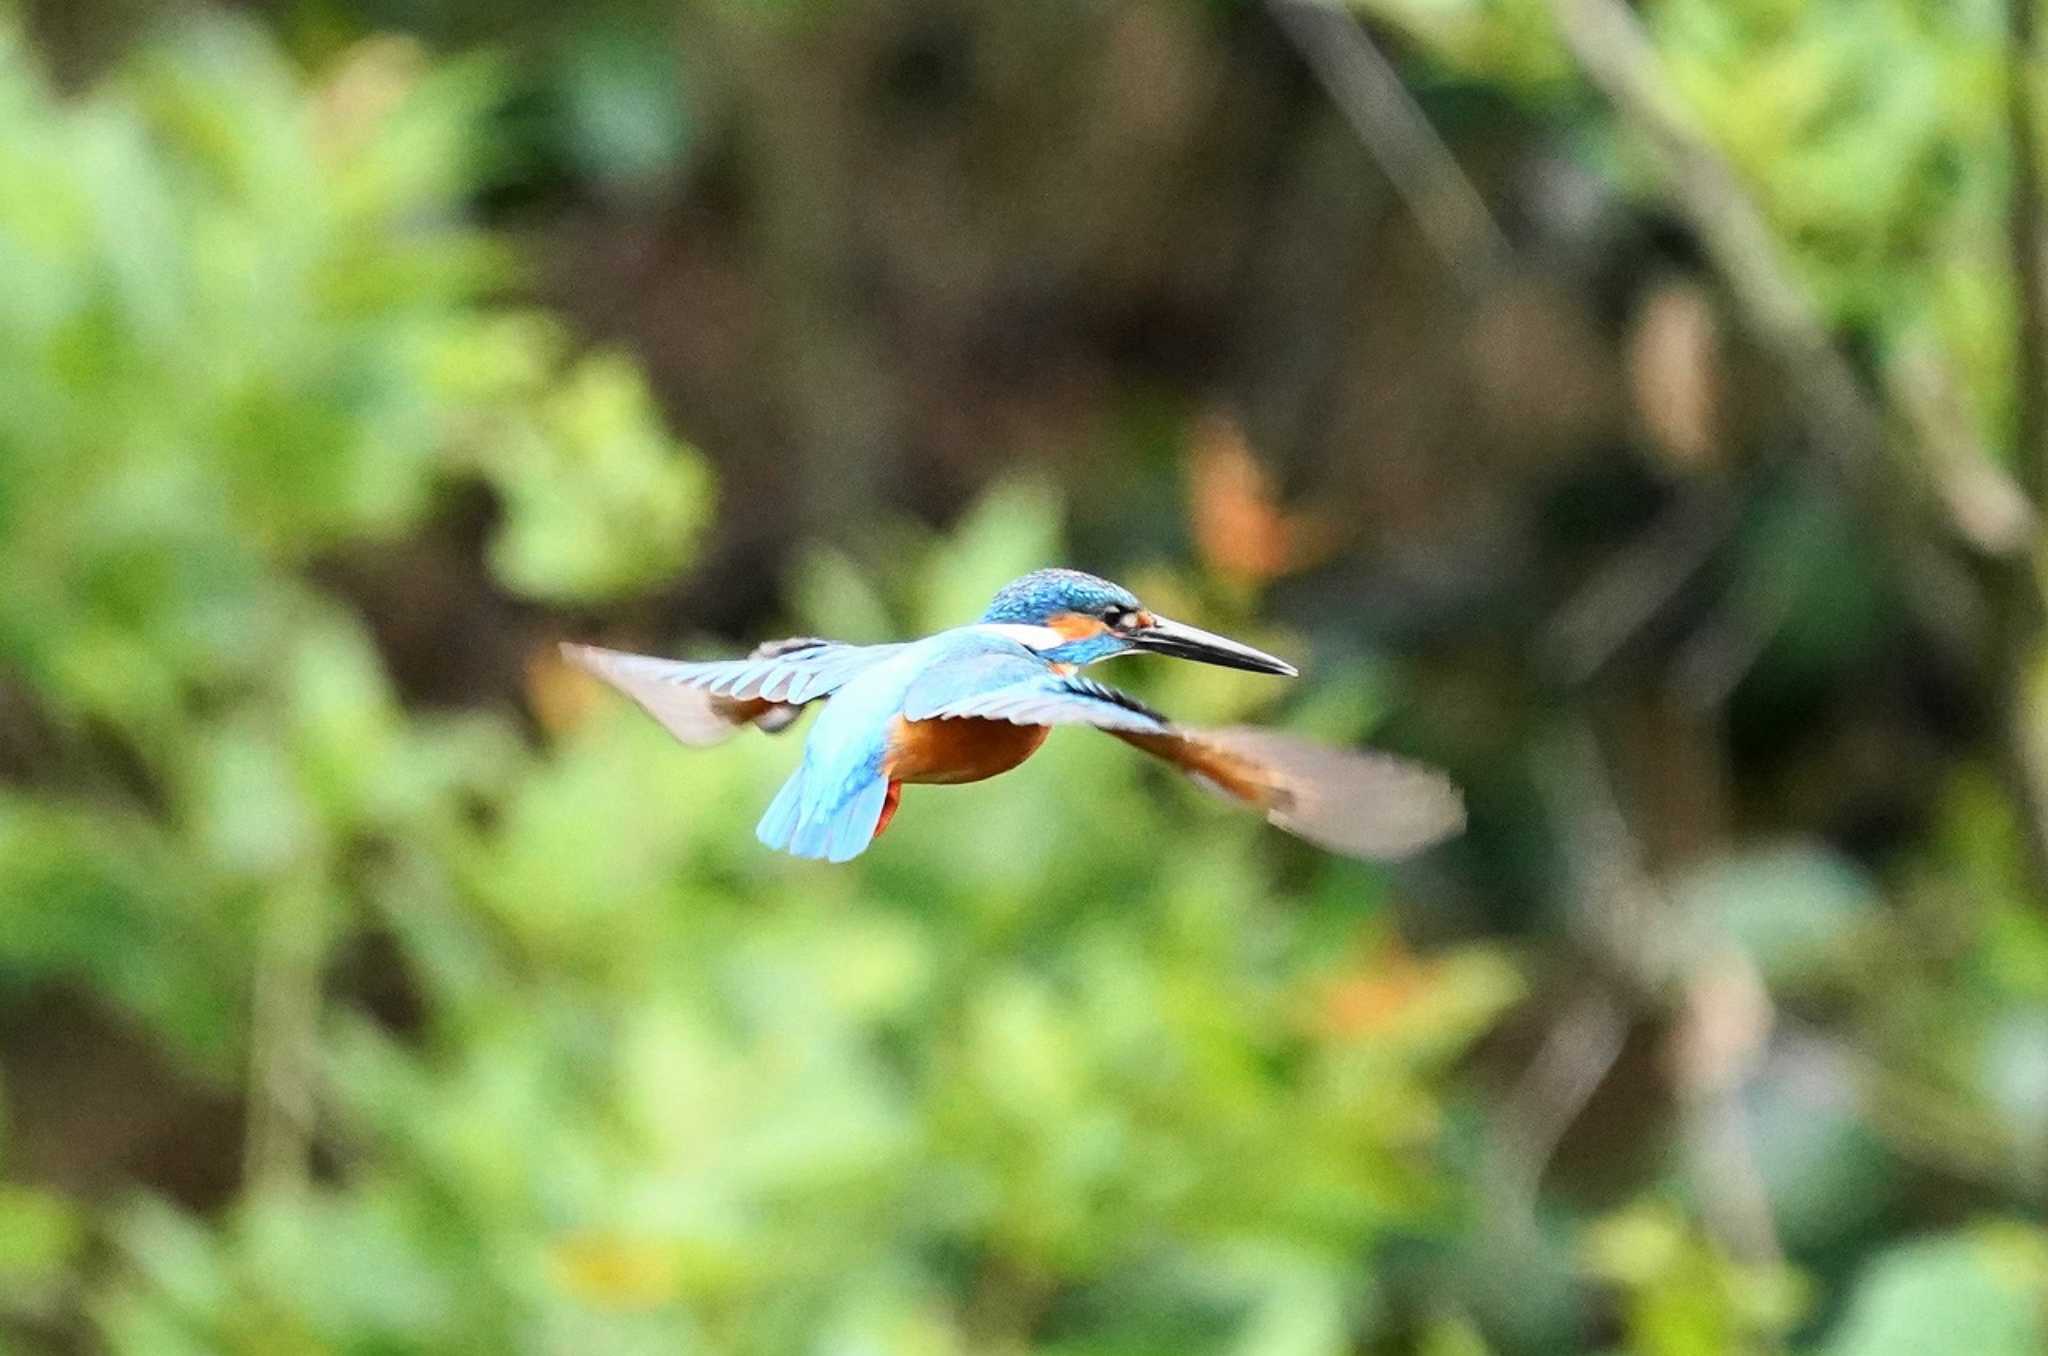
[1360,0,2013,456]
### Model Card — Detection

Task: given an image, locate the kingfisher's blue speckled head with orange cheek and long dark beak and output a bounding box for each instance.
[981,569,1294,678]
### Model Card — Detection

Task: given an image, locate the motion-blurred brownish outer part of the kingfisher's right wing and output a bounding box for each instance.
[1116,727,1464,860]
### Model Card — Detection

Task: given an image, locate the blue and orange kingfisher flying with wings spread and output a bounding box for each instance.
[561,569,1464,862]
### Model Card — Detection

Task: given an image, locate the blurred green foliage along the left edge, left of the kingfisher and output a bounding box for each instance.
[0,13,707,1067]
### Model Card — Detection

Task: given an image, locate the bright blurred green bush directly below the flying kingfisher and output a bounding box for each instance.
[44,462,1516,1352]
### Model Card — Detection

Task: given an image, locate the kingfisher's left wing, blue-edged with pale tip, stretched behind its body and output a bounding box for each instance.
[561,635,903,746]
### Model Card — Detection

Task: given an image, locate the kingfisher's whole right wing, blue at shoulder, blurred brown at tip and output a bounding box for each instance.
[903,658,1464,858]
